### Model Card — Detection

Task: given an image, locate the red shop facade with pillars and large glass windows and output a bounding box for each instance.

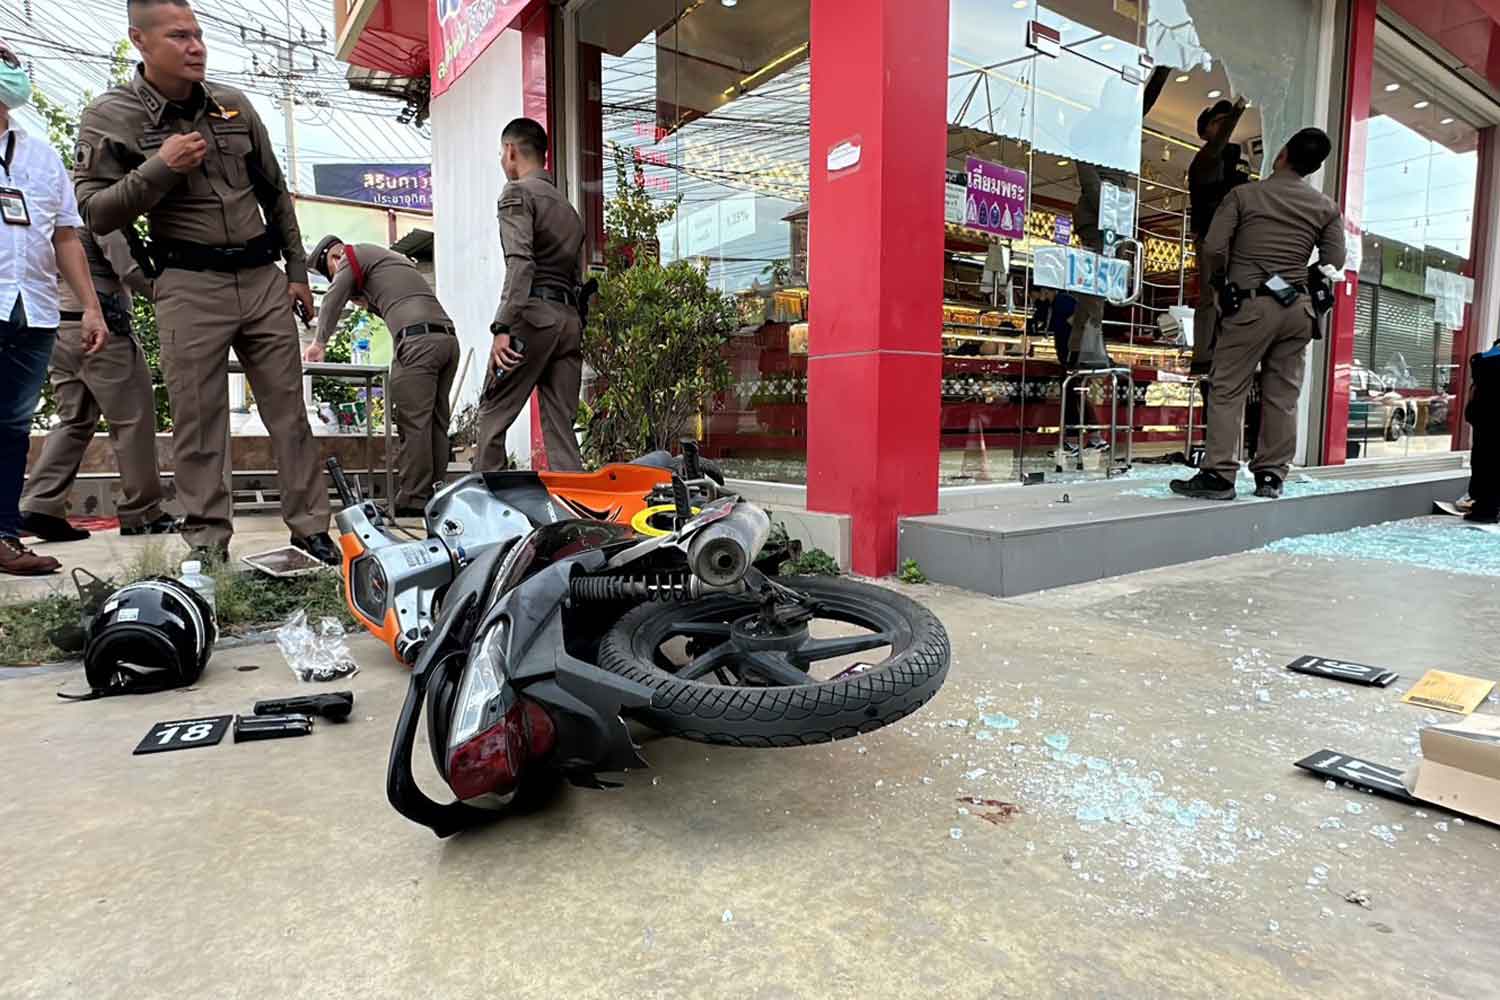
[335,0,1500,574]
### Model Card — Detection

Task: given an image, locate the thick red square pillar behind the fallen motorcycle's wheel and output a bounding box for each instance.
[807,0,948,576]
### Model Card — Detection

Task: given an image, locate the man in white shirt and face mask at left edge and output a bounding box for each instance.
[0,39,110,576]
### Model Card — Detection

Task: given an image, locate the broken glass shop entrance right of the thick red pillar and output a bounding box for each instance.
[942,0,1319,483]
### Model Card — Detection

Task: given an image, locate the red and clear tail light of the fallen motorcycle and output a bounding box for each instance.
[447,621,557,799]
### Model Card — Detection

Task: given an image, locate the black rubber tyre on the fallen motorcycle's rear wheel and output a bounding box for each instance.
[599,577,951,747]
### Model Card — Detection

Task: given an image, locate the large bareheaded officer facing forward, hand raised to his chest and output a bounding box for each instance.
[74,0,339,564]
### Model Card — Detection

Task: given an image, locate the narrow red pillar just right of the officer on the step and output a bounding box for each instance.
[1323,0,1380,465]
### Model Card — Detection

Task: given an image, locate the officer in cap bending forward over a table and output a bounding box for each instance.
[303,235,459,517]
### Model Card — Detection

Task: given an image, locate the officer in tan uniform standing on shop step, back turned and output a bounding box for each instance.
[1172,129,1344,499]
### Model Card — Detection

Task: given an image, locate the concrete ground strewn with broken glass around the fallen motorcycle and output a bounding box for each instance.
[0,542,1500,1000]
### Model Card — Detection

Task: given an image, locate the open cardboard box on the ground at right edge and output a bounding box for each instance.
[1406,715,1500,823]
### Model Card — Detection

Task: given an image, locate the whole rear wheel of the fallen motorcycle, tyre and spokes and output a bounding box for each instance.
[599,577,950,747]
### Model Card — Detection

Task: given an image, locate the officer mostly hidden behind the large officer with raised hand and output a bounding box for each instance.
[21,229,177,541]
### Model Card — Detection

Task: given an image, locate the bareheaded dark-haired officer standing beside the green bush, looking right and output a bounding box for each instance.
[486,118,584,472]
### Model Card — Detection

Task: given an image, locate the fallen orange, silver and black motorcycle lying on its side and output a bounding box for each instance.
[330,462,950,837]
